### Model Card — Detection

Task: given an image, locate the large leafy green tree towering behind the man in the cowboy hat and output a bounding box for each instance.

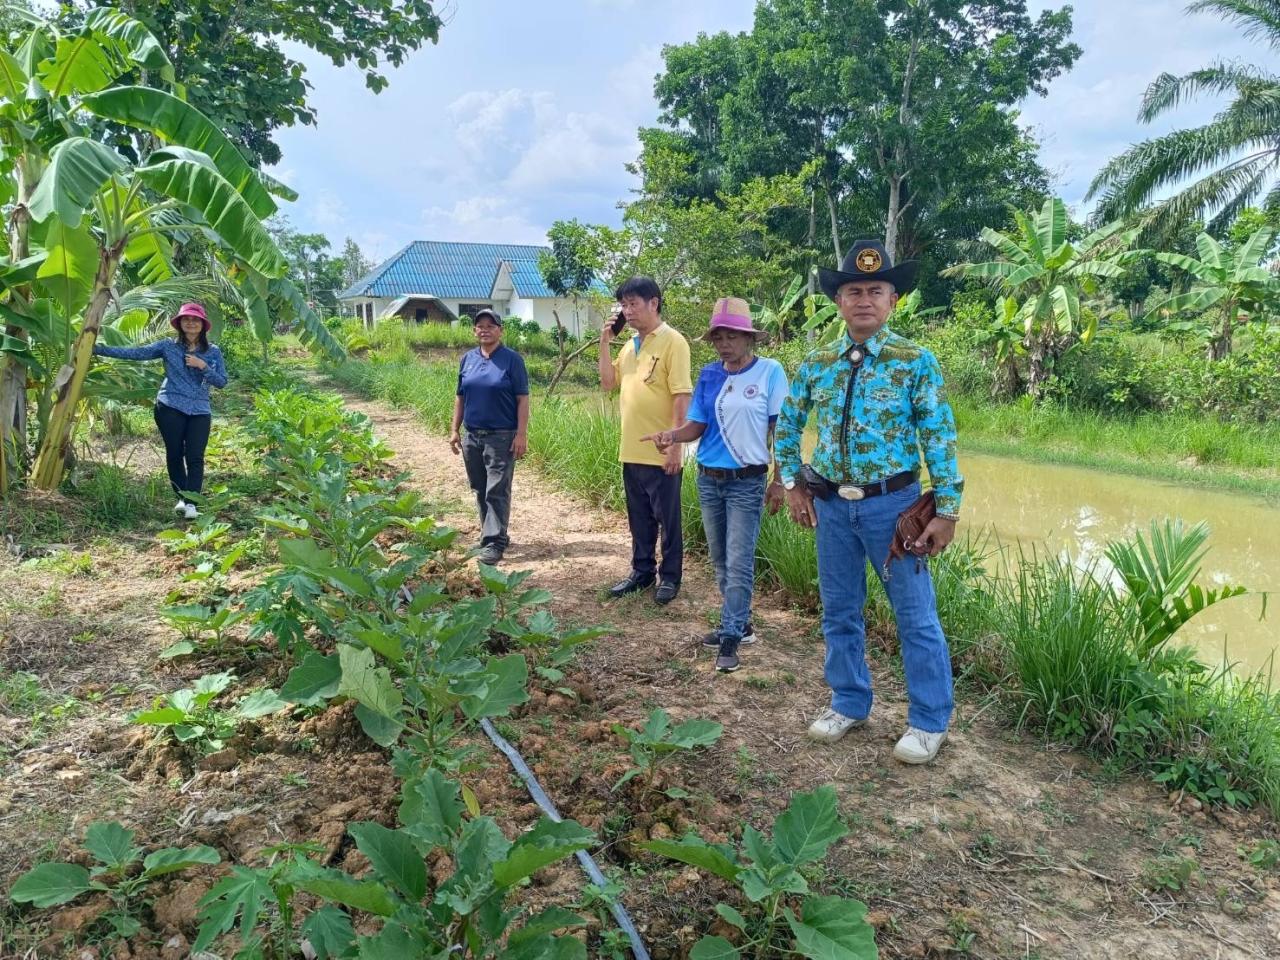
[640,0,1080,289]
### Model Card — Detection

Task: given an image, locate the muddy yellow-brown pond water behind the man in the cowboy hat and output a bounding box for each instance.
[960,454,1280,686]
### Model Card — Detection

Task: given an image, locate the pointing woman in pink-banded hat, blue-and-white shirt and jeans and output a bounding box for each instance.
[643,297,787,673]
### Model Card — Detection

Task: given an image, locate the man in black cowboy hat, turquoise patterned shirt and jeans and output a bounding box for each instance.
[774,239,964,763]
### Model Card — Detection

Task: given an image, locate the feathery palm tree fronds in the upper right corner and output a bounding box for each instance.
[1088,0,1280,234]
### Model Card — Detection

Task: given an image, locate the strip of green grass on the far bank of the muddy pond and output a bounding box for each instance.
[951,396,1280,498]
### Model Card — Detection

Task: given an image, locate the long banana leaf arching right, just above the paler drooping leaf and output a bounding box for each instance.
[81,86,276,217]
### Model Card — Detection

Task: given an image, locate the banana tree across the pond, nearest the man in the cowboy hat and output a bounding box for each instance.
[943,197,1143,399]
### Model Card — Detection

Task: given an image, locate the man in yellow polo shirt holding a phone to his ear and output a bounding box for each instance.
[600,276,694,604]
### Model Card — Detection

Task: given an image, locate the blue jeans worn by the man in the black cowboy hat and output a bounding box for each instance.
[814,484,952,733]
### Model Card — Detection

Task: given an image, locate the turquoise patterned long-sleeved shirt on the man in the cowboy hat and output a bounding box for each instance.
[774,326,964,516]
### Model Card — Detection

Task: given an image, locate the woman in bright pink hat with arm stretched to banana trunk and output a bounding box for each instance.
[93,303,227,520]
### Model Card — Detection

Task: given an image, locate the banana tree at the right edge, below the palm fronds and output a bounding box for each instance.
[1147,227,1277,360]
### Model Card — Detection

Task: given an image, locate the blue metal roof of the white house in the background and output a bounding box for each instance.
[338,241,553,301]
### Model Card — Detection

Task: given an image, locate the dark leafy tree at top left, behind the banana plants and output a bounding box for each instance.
[69,0,442,165]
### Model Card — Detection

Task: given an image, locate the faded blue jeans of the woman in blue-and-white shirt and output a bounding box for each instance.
[698,474,764,640]
